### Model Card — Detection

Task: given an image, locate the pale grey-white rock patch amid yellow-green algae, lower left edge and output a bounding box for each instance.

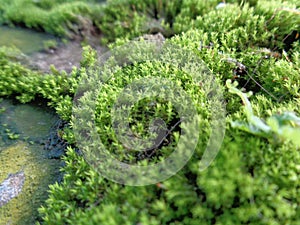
[0,171,25,207]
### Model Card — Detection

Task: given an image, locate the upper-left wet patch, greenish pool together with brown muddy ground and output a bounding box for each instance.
[0,24,107,73]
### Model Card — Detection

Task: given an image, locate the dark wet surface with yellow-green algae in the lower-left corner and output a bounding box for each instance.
[0,100,61,225]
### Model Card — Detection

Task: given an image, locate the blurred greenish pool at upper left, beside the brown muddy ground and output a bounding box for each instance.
[0,26,55,54]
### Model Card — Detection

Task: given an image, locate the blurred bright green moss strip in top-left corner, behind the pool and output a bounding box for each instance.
[0,0,99,37]
